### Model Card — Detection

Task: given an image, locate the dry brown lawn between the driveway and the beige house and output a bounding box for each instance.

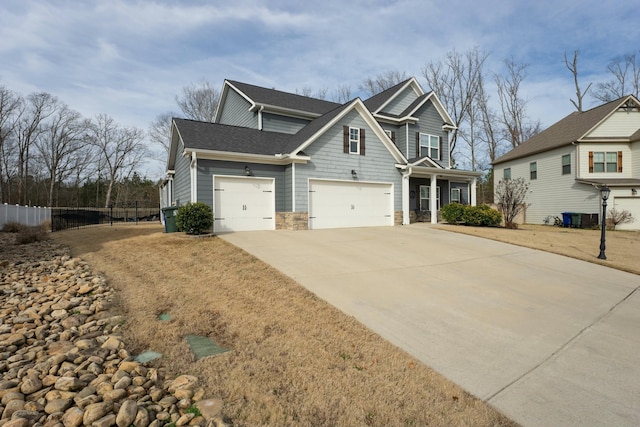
[437,224,640,274]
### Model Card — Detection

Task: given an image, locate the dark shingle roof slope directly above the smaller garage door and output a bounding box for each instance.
[173,118,292,155]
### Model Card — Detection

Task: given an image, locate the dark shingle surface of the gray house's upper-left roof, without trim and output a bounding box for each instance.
[227,80,340,114]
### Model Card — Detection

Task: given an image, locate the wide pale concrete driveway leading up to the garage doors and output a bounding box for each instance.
[220,224,640,426]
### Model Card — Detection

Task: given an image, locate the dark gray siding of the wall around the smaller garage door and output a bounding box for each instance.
[198,159,284,212]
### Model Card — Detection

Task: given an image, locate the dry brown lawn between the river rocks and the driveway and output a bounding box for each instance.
[53,225,515,426]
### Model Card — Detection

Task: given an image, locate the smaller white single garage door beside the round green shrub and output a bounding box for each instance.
[213,175,276,232]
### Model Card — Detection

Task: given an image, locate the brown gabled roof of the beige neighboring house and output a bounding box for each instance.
[493,95,639,165]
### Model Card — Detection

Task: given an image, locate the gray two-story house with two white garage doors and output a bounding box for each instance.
[161,78,480,232]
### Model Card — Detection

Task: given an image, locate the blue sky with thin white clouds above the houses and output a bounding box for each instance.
[0,0,640,175]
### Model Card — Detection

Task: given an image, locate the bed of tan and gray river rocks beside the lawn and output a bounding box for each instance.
[0,233,226,427]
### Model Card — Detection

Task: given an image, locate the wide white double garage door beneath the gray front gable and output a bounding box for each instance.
[309,180,393,229]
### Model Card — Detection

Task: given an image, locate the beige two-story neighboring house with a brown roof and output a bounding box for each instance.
[493,95,640,229]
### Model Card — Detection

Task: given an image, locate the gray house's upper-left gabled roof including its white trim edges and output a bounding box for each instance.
[216,80,340,119]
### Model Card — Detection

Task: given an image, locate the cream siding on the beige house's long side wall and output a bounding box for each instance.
[494,146,600,224]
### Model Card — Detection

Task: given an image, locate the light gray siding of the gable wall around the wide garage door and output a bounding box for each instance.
[295,111,402,212]
